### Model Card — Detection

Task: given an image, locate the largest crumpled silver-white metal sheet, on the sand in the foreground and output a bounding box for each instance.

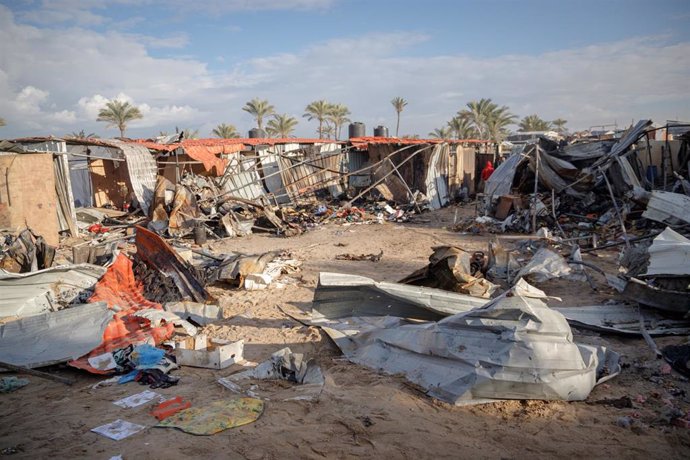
[314,280,620,405]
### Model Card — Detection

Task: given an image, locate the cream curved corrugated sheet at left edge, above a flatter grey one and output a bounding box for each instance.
[0,264,106,317]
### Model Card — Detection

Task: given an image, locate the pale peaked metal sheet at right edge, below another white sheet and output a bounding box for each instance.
[645,227,690,276]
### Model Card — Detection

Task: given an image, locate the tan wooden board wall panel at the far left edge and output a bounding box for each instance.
[0,153,60,246]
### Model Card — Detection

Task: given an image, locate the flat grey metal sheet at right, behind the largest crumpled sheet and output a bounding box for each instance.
[554,304,690,336]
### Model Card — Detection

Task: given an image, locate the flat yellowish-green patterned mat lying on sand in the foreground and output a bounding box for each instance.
[156,398,264,436]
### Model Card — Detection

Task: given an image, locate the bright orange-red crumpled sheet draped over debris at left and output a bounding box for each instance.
[68,254,175,374]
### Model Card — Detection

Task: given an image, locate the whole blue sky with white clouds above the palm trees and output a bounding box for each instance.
[0,0,690,137]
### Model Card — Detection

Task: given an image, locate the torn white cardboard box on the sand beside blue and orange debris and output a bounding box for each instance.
[175,334,244,369]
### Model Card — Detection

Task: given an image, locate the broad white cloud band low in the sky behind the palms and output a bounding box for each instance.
[0,0,690,137]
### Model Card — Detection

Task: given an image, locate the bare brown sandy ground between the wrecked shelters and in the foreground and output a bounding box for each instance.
[0,207,690,459]
